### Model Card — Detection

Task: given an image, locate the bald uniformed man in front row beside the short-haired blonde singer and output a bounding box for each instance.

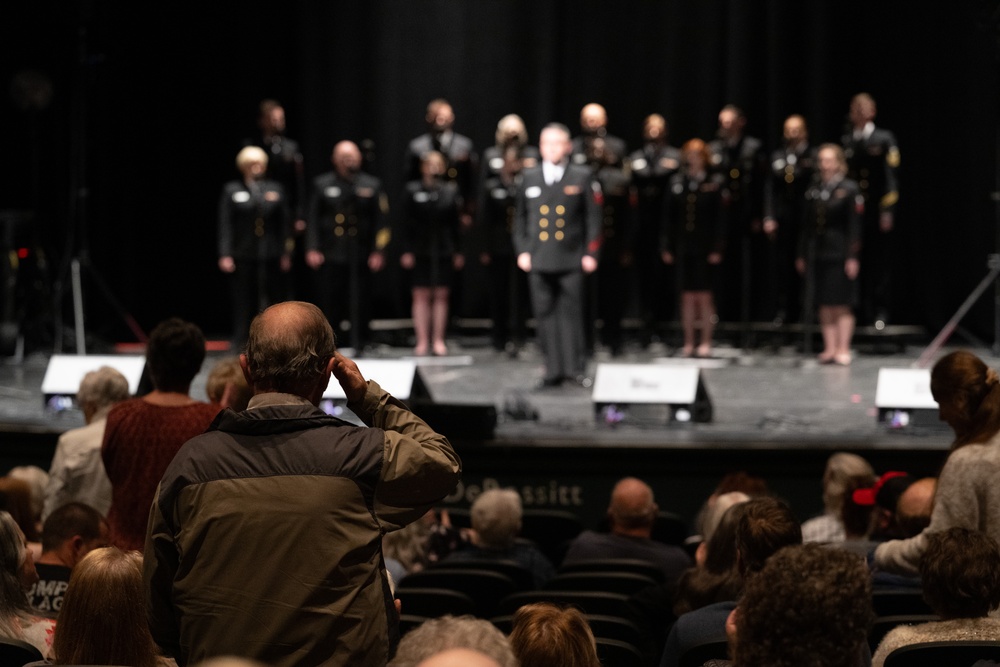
[306,141,390,351]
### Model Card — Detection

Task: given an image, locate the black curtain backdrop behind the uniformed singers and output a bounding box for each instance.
[0,0,1000,350]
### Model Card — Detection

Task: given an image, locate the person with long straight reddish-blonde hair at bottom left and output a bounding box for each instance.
[43,547,174,667]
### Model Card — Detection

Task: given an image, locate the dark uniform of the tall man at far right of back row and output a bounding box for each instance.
[842,127,899,324]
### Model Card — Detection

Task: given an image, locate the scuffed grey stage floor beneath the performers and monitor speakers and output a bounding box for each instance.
[0,341,968,450]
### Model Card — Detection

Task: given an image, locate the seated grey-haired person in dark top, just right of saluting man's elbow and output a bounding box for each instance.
[444,489,556,588]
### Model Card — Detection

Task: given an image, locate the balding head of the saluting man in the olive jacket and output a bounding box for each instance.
[240,301,337,402]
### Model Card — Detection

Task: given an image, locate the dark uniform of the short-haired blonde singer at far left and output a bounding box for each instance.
[218,179,293,345]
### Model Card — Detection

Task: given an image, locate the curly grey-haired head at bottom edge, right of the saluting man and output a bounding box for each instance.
[388,615,518,667]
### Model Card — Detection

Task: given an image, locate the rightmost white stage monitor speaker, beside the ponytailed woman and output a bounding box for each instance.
[875,368,944,428]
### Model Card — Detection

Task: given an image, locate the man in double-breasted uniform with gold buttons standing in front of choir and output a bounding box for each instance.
[515,123,601,387]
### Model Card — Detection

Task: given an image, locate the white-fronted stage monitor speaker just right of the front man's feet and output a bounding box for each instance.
[591,364,712,425]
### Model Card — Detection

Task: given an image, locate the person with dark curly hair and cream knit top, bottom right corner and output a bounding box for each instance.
[872,528,1000,667]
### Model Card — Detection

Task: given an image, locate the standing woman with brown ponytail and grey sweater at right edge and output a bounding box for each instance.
[875,351,1000,575]
